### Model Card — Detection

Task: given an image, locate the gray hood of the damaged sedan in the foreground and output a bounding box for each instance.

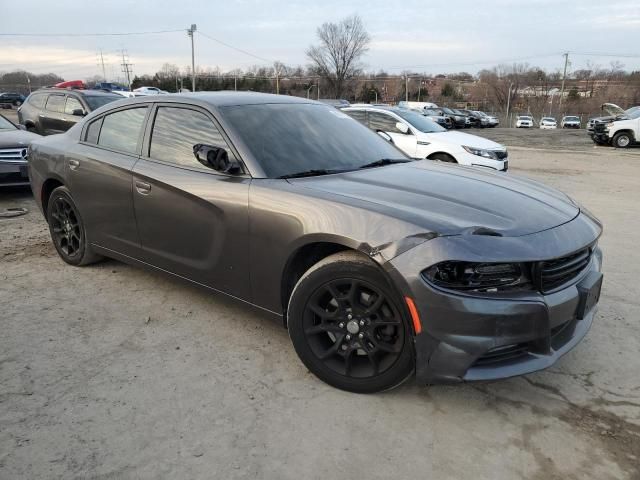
[290,160,580,237]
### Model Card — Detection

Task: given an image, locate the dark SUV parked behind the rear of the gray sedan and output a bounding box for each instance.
[18,88,123,135]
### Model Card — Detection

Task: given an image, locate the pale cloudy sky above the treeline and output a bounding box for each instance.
[0,0,640,80]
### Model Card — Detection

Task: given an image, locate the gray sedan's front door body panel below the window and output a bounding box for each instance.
[133,159,250,298]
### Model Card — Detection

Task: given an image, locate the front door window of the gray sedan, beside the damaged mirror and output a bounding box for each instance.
[149,107,233,171]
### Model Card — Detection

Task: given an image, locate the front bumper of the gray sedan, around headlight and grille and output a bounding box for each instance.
[390,214,602,383]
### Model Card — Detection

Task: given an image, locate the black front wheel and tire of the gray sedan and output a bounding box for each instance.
[287,251,415,393]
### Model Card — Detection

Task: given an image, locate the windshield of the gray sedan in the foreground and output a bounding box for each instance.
[220,103,407,178]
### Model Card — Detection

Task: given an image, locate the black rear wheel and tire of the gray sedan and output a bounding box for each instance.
[47,186,102,266]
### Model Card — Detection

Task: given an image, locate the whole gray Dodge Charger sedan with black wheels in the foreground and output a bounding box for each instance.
[29,92,602,392]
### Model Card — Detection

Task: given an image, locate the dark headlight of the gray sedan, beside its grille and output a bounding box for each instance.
[422,261,531,292]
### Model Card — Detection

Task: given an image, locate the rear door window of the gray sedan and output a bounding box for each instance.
[98,107,147,154]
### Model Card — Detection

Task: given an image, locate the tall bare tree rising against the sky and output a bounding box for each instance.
[307,15,371,98]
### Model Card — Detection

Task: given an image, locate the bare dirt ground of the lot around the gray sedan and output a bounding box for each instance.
[0,125,640,480]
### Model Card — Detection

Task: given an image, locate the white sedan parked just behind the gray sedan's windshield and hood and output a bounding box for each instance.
[342,107,509,171]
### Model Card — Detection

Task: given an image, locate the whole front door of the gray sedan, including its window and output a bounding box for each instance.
[133,103,251,298]
